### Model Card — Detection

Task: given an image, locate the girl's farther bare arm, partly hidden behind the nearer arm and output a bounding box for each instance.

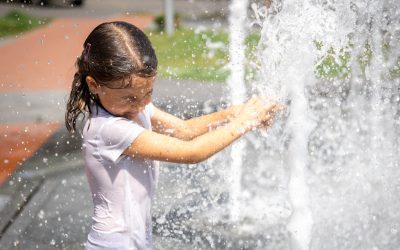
[151,105,242,140]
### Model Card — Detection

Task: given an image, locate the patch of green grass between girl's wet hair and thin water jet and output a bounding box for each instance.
[146,28,259,82]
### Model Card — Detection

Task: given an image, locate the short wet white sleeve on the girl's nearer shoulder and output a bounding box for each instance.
[96,118,145,163]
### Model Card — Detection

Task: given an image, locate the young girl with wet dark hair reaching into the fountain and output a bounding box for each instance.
[65,22,280,249]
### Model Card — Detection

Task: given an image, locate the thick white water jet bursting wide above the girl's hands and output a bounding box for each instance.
[262,1,321,249]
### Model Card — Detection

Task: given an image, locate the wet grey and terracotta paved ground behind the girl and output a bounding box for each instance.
[0,1,228,249]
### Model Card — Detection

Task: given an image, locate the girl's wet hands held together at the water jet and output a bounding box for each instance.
[238,96,284,129]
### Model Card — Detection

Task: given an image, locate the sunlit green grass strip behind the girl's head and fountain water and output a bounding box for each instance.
[146,28,400,82]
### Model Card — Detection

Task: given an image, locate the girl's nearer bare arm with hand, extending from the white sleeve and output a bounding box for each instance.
[124,99,279,163]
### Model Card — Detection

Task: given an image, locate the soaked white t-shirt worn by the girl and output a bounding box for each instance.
[83,103,158,250]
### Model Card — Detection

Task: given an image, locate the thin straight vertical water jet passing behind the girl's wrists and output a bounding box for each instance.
[228,0,248,221]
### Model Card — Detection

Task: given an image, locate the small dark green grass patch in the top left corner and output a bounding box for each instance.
[0,10,50,37]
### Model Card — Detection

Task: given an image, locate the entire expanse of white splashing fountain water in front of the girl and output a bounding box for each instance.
[159,0,400,250]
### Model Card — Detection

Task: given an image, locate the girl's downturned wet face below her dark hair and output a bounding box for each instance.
[86,76,155,119]
